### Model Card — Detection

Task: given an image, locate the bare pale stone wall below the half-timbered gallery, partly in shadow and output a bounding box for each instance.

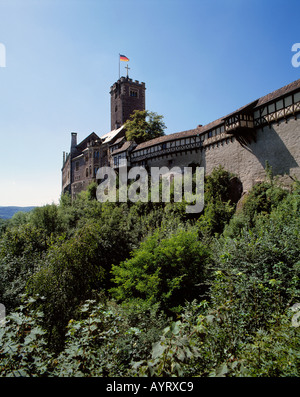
[201,114,300,191]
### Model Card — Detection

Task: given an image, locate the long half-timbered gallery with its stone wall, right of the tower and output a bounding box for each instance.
[131,79,300,190]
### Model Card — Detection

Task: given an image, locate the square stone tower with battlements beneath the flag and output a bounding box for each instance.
[110,77,146,130]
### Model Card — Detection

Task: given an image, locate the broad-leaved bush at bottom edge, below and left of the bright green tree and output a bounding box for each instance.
[53,300,165,376]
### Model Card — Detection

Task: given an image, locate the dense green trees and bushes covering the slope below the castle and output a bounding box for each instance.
[0,168,300,377]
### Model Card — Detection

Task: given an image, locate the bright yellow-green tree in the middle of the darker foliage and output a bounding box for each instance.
[111,227,209,311]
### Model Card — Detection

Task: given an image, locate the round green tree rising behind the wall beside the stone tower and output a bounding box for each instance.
[125,110,166,144]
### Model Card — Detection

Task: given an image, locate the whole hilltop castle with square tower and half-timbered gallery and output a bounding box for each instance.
[62,76,300,197]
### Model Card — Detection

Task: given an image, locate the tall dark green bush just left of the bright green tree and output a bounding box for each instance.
[27,222,107,344]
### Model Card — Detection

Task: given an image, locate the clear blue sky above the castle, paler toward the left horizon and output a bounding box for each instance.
[0,0,300,206]
